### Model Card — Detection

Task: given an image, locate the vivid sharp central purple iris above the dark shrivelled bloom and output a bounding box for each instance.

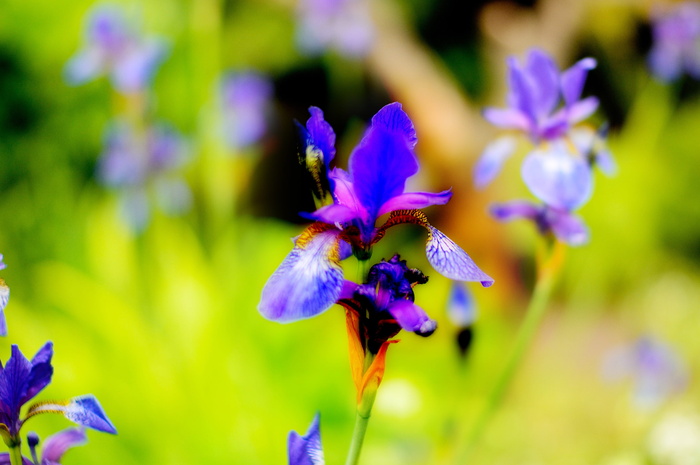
[258,103,493,322]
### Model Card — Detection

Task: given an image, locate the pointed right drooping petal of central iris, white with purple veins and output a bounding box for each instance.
[425,225,493,287]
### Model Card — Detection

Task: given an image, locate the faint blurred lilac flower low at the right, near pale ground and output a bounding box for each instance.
[603,336,688,407]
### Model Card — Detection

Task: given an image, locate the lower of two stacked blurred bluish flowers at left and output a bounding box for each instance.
[98,121,191,230]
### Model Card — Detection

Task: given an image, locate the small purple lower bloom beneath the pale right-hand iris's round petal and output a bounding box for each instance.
[491,200,588,246]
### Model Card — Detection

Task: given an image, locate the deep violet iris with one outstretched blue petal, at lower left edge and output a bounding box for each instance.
[0,342,117,454]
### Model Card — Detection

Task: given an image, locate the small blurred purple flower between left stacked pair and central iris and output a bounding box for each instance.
[221,72,273,149]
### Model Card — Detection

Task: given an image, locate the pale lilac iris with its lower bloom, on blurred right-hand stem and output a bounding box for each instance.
[474,49,615,245]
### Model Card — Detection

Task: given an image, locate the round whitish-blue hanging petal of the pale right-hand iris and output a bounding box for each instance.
[522,146,593,210]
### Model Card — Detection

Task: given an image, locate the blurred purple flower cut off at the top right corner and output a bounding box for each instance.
[648,1,700,81]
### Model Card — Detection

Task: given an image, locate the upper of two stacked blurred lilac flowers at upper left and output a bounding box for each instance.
[65,5,168,93]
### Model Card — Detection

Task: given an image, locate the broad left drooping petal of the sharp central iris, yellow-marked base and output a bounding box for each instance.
[258,225,343,323]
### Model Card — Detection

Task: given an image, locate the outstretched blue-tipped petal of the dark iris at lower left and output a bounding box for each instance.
[27,394,117,434]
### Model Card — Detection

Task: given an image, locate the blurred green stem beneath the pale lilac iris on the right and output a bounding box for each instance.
[455,237,565,464]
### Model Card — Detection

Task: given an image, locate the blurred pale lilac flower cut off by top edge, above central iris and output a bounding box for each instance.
[297,0,375,58]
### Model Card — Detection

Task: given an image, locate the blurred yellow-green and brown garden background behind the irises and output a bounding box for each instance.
[0,0,700,465]
